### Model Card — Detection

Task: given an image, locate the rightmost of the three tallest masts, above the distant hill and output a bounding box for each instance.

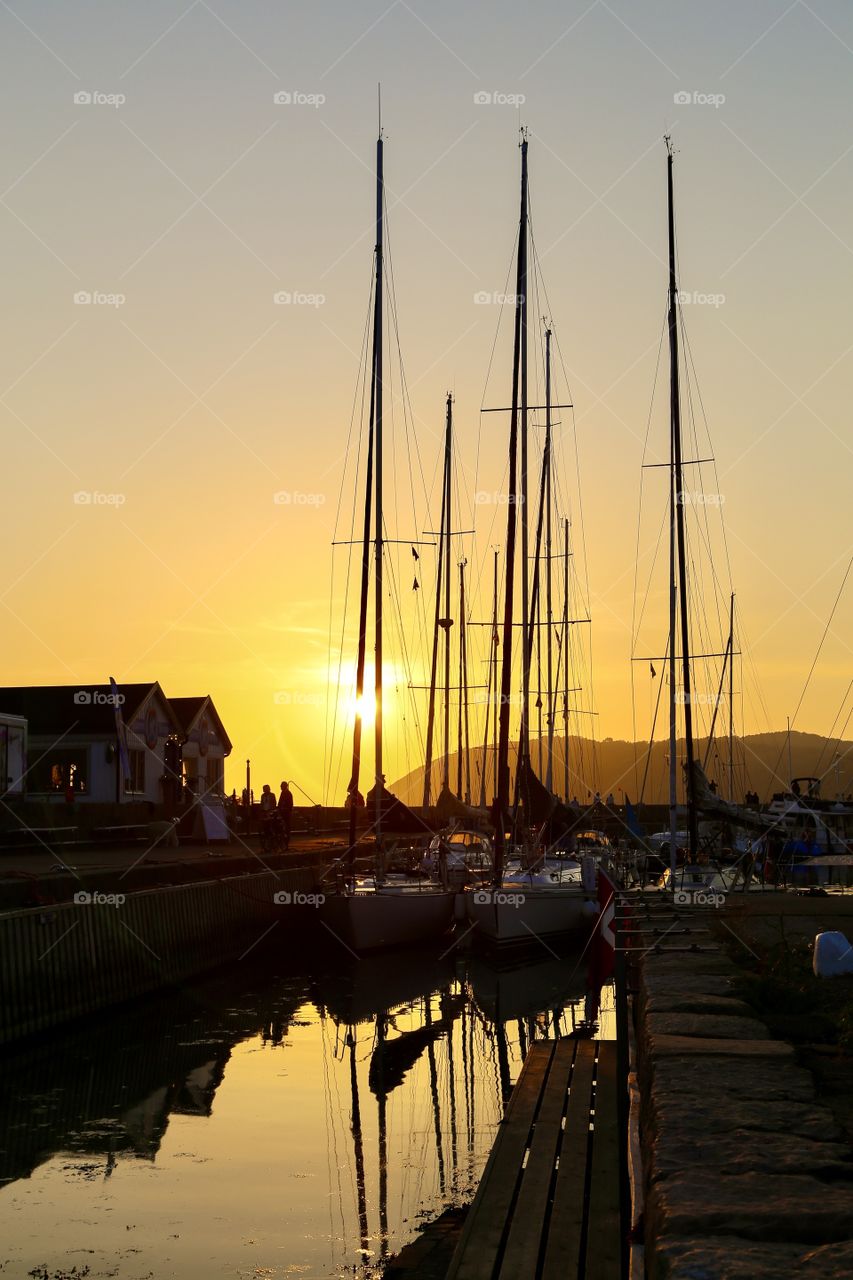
[666,137,699,861]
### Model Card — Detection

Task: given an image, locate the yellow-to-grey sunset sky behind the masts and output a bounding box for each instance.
[0,0,853,800]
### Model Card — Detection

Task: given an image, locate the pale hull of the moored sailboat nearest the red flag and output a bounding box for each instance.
[465,886,589,943]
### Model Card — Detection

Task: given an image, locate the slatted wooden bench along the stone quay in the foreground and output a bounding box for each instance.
[447,1039,622,1280]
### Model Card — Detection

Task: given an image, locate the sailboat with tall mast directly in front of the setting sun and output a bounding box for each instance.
[320,124,453,952]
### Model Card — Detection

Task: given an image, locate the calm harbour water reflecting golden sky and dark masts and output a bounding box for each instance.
[0,936,612,1280]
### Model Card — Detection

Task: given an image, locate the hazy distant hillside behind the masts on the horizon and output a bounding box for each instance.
[391,731,853,804]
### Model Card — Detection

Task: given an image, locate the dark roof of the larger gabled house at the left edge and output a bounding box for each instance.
[0,680,174,737]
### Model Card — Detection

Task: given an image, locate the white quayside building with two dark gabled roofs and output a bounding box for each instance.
[0,681,231,805]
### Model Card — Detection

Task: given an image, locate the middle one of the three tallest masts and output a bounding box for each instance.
[494,137,528,884]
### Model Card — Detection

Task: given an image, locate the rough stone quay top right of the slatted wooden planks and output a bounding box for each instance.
[638,951,853,1280]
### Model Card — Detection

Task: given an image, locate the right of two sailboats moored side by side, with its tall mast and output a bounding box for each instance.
[465,132,594,943]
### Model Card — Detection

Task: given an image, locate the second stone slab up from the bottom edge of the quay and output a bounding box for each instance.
[647,1169,853,1244]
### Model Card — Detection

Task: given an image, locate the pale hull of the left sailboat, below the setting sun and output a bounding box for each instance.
[320,886,455,952]
